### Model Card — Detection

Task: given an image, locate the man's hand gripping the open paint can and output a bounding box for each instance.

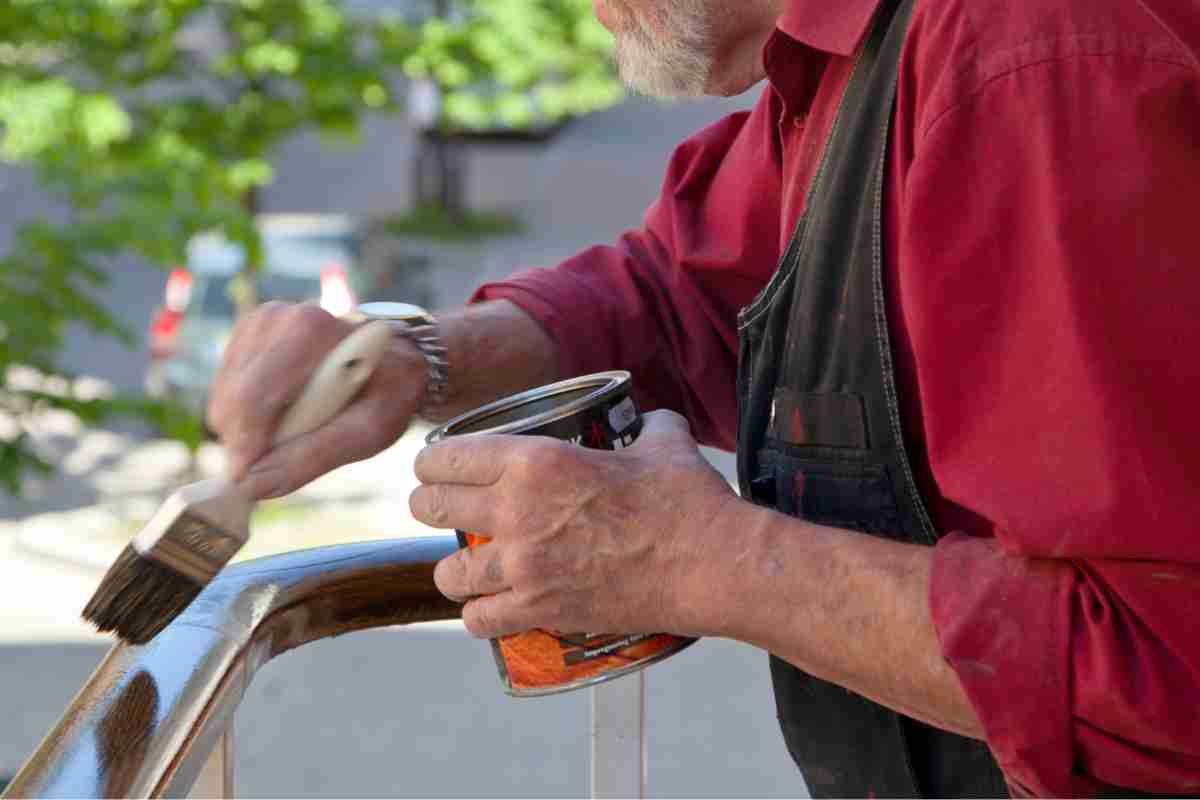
[409,411,738,637]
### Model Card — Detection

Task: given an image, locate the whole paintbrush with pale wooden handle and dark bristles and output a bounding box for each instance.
[83,321,395,644]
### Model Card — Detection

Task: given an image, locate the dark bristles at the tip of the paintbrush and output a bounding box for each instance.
[83,545,204,644]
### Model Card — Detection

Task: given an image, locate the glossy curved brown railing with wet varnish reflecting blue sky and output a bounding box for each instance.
[2,536,460,798]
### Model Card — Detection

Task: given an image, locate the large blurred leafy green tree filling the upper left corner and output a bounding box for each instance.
[0,0,416,493]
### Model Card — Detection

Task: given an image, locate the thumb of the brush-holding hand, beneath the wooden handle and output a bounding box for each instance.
[238,354,424,499]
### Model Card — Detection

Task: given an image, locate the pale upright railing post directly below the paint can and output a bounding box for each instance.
[592,670,646,798]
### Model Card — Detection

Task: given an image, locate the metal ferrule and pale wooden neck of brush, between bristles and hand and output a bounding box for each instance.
[131,479,252,585]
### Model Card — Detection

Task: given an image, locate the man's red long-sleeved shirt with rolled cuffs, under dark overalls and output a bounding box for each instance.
[476,0,1200,795]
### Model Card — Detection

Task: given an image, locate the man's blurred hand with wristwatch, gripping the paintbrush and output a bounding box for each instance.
[208,302,426,499]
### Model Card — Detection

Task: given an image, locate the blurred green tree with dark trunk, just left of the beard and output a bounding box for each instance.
[396,0,623,231]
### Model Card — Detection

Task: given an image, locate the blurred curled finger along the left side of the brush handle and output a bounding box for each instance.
[221,306,353,477]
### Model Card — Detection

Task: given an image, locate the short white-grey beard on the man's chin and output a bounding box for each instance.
[616,0,715,98]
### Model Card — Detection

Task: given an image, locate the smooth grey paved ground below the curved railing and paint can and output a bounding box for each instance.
[0,628,806,798]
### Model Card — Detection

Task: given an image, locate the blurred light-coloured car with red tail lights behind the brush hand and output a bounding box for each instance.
[145,215,428,416]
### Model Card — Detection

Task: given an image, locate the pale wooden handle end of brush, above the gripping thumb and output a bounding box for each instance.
[272,321,395,446]
